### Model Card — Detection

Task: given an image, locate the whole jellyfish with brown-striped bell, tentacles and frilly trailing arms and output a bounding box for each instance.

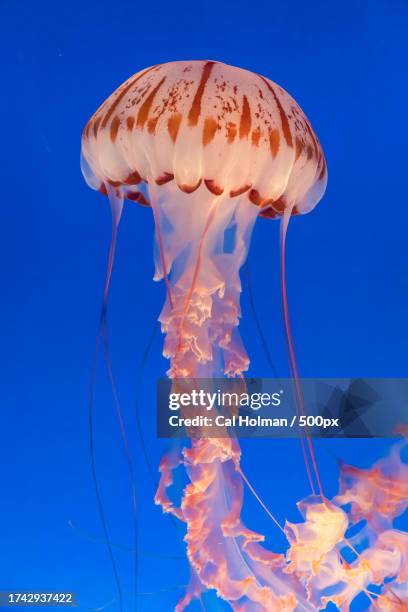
[81,61,407,612]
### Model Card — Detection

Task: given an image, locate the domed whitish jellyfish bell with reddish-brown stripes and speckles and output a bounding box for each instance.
[82,61,327,217]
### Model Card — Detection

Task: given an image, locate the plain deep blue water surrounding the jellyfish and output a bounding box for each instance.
[0,0,408,611]
